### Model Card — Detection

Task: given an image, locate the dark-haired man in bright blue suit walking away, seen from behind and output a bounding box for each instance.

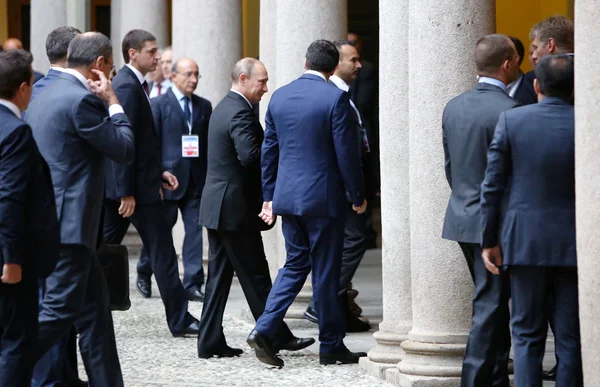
[247,40,367,366]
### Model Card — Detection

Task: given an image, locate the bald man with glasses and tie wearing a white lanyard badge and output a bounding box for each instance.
[144,58,212,301]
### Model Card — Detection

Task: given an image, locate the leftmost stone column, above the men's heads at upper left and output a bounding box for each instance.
[29,0,67,74]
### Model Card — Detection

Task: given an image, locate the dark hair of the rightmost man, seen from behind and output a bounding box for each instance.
[535,54,575,101]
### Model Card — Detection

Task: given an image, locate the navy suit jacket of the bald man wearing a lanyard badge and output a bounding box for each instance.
[151,86,212,200]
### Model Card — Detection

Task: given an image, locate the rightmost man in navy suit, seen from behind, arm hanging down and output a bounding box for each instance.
[481,55,583,387]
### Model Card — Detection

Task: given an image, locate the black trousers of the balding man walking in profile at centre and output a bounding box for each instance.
[198,229,294,353]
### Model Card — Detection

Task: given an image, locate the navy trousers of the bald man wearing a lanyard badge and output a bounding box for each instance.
[137,183,204,290]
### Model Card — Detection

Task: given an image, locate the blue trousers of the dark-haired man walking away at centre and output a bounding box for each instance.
[256,215,346,353]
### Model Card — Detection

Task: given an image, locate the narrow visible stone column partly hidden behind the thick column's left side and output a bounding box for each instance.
[361,0,412,379]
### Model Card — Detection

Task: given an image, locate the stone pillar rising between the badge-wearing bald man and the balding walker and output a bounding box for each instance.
[172,0,242,107]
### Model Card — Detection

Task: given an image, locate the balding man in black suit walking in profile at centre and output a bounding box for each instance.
[198,58,315,358]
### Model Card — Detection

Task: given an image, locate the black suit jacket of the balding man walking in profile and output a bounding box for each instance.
[199,91,266,230]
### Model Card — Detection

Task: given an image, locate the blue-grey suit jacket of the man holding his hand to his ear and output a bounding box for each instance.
[27,73,134,250]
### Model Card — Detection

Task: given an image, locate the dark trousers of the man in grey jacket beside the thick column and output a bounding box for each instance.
[460,242,510,387]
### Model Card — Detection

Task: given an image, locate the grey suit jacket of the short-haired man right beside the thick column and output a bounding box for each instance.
[442,82,517,243]
